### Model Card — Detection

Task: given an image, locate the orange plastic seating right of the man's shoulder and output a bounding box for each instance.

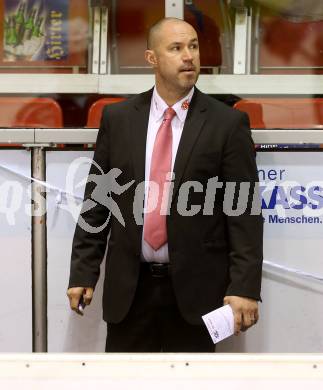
[234,98,323,129]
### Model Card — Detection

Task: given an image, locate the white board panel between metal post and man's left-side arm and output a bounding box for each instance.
[46,151,106,352]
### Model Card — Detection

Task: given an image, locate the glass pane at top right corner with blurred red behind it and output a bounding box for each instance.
[253,0,323,74]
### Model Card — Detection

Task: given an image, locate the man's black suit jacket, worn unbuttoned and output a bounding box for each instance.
[69,88,263,324]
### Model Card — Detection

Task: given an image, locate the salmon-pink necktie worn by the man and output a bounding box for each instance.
[144,107,176,250]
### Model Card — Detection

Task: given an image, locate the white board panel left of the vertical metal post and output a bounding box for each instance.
[0,150,32,353]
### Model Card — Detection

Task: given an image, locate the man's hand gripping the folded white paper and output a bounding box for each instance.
[223,295,258,335]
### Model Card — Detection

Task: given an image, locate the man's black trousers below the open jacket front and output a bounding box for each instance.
[106,264,215,352]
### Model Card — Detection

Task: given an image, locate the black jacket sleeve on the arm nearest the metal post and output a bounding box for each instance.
[69,107,110,287]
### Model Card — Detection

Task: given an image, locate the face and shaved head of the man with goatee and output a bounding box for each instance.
[148,21,200,92]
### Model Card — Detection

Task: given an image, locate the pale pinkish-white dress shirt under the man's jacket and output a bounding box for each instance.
[141,87,194,263]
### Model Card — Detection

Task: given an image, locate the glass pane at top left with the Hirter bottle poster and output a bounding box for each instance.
[0,0,89,73]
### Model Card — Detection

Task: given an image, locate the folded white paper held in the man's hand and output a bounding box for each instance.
[202,305,234,344]
